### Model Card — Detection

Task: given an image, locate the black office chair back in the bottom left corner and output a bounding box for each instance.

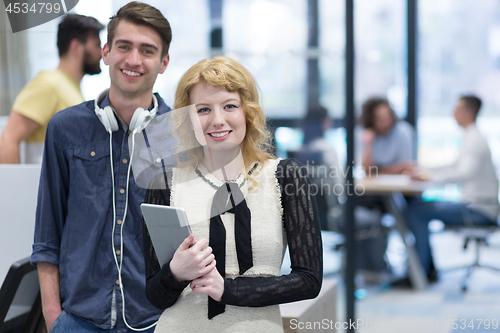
[0,257,45,333]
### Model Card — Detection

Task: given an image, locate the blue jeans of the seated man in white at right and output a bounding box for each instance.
[407,201,496,273]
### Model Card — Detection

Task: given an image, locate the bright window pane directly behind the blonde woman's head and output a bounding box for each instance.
[222,0,307,118]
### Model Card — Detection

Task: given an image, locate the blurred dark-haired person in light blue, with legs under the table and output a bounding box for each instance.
[355,97,414,272]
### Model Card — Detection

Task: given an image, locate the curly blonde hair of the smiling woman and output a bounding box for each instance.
[172,56,273,179]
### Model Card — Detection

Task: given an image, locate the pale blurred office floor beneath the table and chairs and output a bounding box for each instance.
[323,231,500,333]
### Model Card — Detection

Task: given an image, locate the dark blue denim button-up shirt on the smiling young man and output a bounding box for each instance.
[31,95,170,332]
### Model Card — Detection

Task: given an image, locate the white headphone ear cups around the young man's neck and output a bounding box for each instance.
[94,89,158,132]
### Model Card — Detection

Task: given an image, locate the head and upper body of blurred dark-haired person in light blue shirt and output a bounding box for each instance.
[359,97,414,175]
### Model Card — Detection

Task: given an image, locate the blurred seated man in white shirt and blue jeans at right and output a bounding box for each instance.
[408,96,499,282]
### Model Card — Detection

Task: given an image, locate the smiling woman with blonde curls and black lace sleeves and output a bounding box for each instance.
[144,57,323,333]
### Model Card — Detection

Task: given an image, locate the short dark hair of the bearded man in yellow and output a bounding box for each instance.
[57,14,104,58]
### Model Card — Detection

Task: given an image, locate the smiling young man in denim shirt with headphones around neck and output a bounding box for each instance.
[31,2,172,333]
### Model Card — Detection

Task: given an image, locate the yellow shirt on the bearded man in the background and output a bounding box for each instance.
[12,69,84,143]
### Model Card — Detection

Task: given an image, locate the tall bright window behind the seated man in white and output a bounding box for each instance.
[418,0,500,167]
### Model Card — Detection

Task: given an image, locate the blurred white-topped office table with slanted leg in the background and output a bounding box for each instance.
[356,175,431,290]
